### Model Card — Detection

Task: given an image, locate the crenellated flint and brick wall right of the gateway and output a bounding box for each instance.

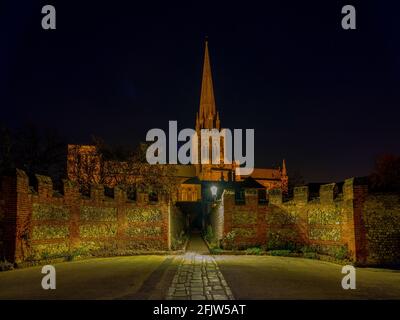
[214,178,400,265]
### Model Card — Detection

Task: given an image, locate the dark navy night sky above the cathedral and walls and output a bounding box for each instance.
[0,0,400,182]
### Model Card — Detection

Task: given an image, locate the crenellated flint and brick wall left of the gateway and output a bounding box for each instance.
[0,170,183,262]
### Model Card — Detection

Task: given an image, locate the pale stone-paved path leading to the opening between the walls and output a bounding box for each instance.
[166,234,234,300]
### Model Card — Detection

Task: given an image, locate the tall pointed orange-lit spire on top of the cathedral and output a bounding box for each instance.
[199,39,216,129]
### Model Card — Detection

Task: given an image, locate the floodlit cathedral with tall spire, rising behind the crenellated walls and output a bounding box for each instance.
[67,41,288,202]
